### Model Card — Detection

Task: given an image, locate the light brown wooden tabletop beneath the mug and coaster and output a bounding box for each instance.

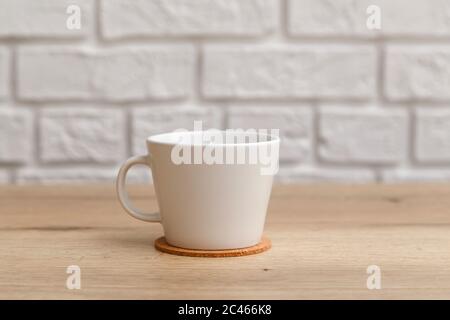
[0,185,450,299]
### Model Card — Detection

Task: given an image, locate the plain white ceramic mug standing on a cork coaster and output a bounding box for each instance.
[117,131,280,250]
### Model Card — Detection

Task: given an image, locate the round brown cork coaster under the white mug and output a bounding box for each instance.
[155,237,272,258]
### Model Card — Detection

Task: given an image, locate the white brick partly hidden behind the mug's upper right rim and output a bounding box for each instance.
[227,107,312,162]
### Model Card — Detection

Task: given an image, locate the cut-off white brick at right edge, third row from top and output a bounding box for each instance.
[415,109,450,162]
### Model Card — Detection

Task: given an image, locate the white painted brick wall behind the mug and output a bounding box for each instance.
[0,0,450,184]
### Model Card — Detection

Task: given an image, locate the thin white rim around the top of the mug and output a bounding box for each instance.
[146,130,280,147]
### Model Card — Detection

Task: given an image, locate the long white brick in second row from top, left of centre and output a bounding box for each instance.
[18,45,194,101]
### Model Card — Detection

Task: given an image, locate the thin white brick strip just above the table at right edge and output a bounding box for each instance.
[381,168,450,183]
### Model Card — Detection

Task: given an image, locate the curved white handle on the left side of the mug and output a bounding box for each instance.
[116,155,161,222]
